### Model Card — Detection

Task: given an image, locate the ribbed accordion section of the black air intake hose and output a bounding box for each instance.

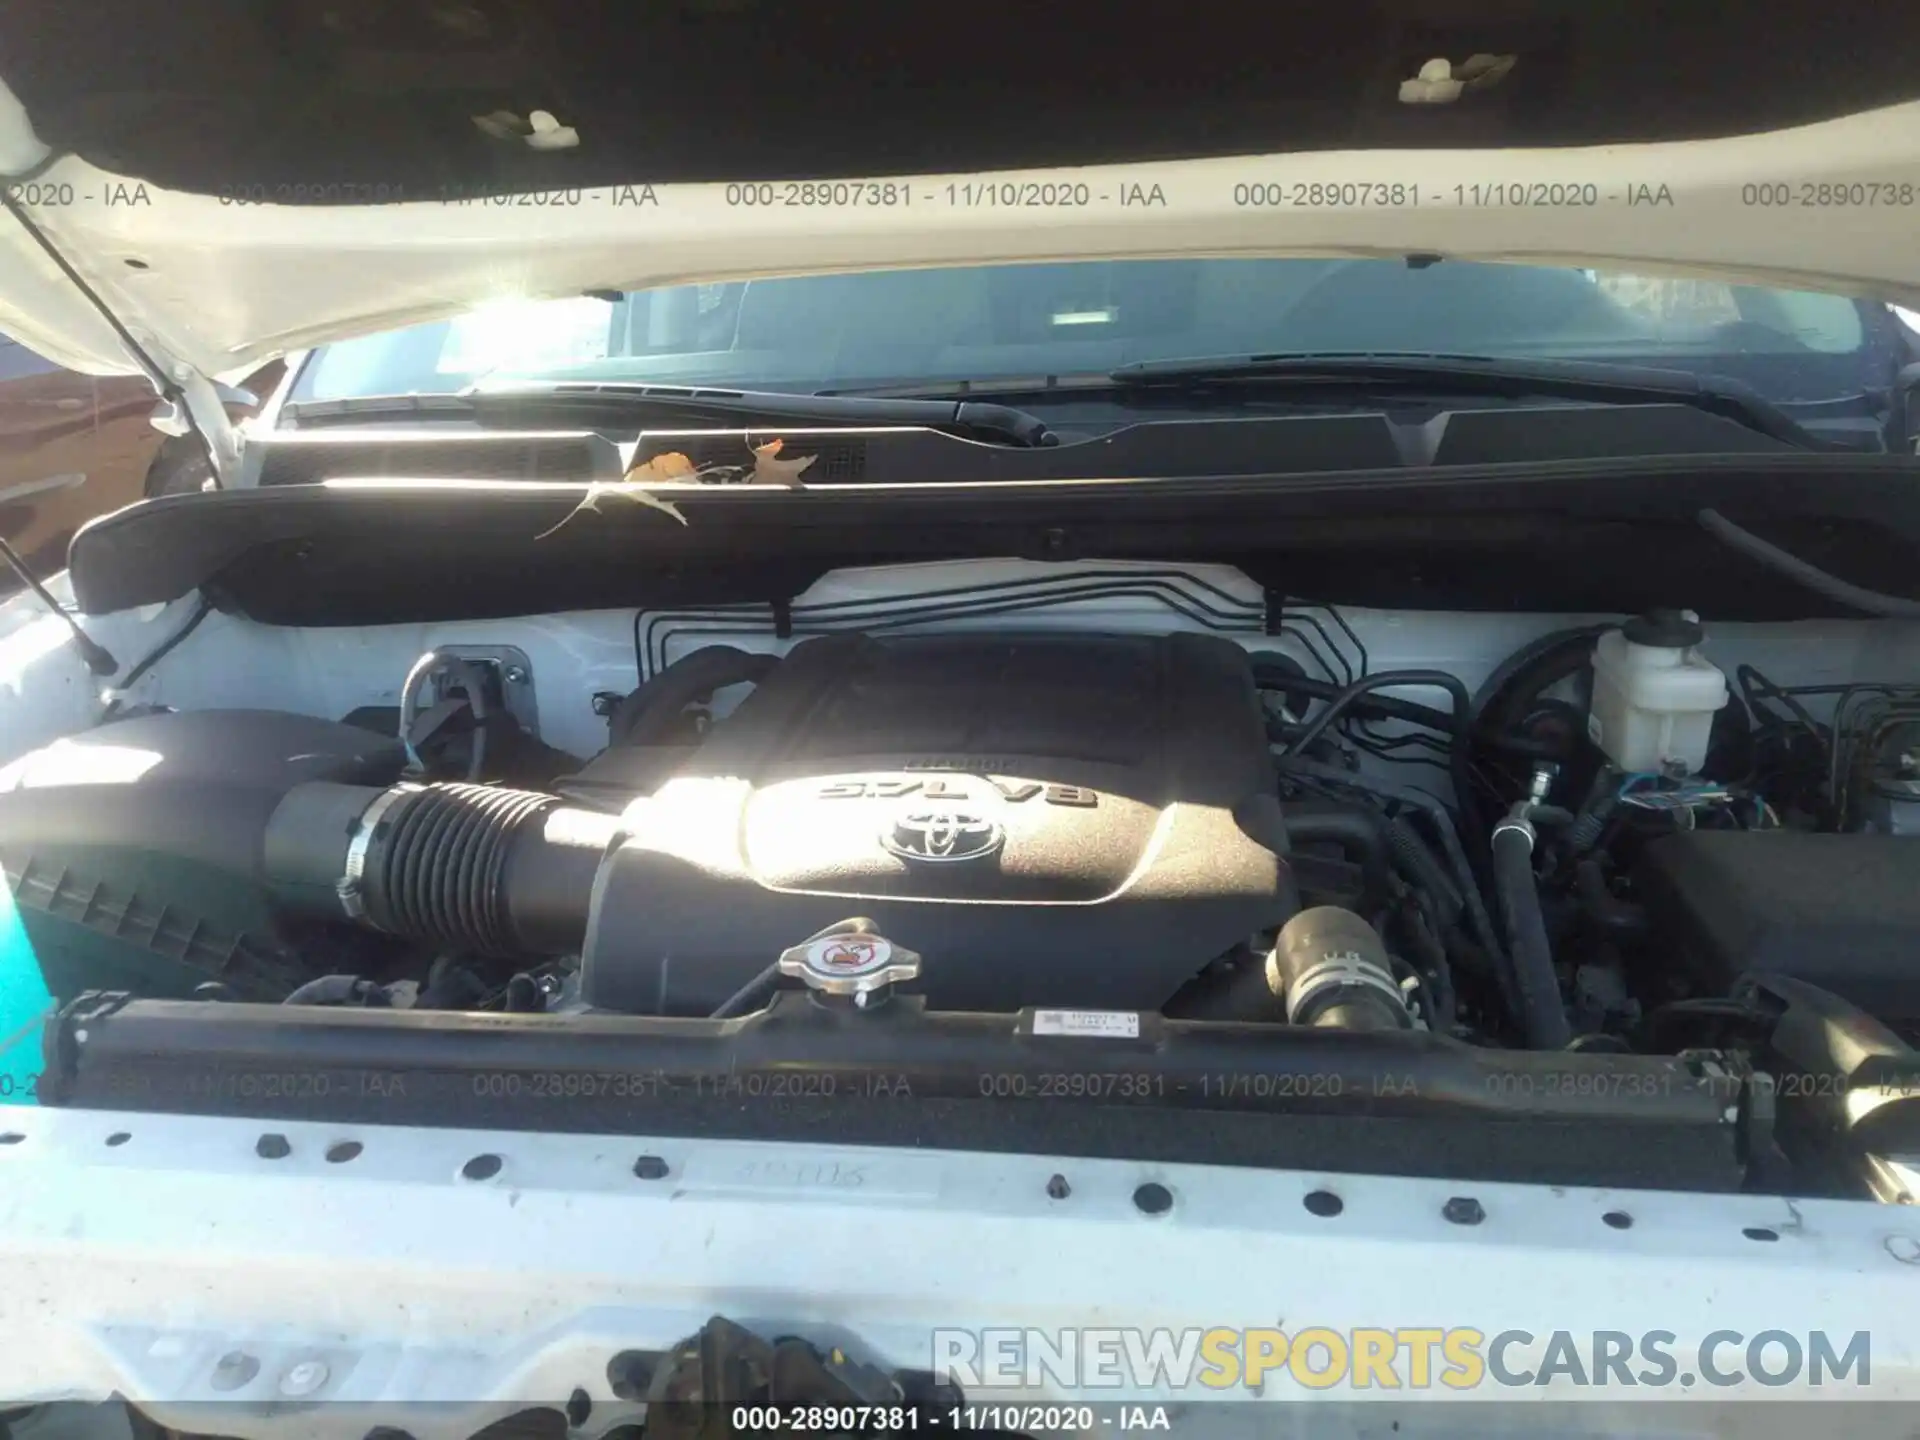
[365,785,561,956]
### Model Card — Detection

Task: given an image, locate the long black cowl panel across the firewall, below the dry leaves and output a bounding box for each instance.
[71,455,1920,626]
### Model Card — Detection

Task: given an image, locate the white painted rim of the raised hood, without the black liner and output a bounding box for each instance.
[0,86,1920,378]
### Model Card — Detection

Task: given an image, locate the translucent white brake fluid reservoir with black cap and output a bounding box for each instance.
[1586,611,1726,774]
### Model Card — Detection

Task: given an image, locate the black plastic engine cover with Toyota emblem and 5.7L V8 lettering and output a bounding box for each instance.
[582,634,1296,1014]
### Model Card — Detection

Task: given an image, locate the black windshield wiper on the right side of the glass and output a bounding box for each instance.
[1108,351,1845,451]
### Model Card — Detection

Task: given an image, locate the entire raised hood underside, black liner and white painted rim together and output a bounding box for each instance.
[0,0,1920,380]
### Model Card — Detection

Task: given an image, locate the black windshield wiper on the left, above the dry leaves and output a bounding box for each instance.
[463,380,1058,447]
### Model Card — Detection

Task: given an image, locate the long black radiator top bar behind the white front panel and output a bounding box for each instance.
[40,993,1751,1190]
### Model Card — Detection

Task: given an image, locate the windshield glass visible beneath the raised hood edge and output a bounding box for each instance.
[290,259,1882,401]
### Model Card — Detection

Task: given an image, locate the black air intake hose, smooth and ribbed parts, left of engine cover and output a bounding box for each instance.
[265,781,620,956]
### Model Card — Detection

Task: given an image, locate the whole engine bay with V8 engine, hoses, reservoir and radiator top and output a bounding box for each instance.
[0,576,1920,1200]
